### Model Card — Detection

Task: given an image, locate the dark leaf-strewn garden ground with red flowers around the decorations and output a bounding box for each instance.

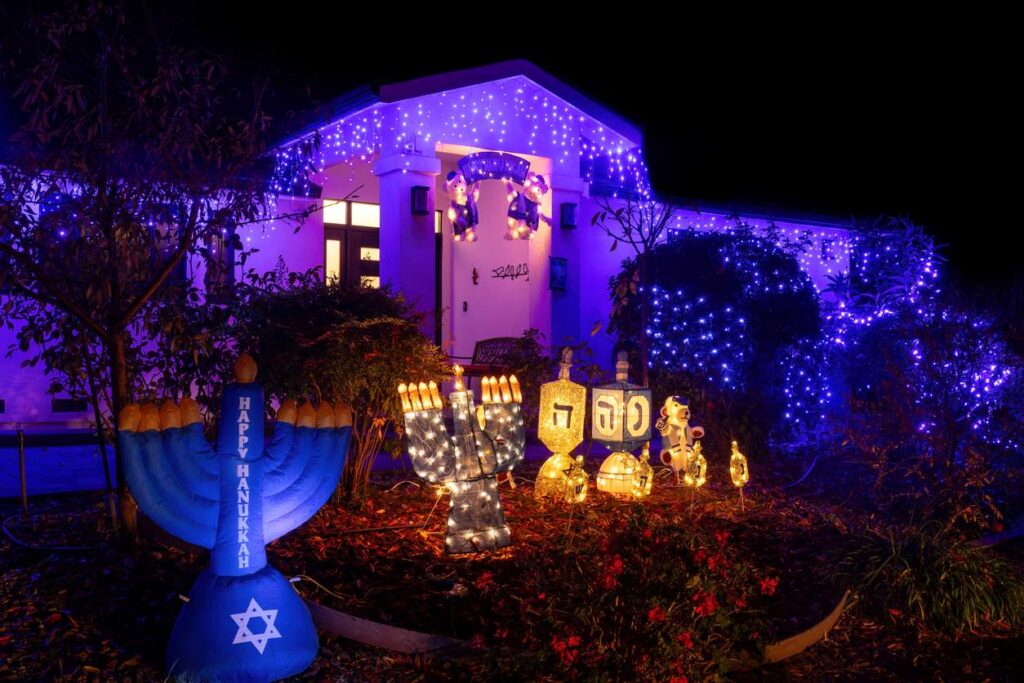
[0,450,1024,681]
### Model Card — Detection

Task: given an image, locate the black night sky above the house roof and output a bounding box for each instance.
[6,0,1024,288]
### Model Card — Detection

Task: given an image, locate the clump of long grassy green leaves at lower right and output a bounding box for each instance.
[839,521,1024,633]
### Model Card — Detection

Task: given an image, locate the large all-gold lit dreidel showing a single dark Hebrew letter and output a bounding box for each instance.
[534,348,589,503]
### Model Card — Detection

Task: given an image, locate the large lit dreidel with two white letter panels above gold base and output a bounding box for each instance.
[591,351,651,498]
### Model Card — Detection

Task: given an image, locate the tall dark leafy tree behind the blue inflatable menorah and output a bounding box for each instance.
[0,0,278,522]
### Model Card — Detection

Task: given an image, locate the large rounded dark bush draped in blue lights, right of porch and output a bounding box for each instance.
[609,223,828,450]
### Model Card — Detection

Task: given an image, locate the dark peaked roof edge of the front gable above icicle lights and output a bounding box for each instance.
[380,59,643,145]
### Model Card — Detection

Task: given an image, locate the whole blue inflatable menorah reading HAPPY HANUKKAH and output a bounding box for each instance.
[118,354,351,682]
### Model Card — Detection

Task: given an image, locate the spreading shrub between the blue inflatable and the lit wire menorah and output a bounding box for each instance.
[228,269,450,500]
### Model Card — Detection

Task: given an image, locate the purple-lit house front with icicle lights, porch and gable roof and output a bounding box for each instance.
[0,61,851,428]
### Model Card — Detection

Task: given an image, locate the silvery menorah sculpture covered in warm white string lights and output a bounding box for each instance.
[398,365,525,555]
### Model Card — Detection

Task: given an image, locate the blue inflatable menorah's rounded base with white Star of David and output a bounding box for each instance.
[167,565,317,683]
